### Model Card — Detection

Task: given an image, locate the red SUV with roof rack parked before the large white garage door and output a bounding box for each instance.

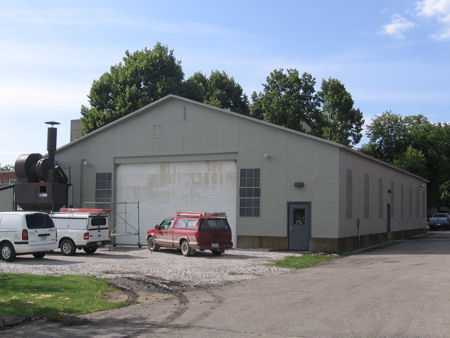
[147,212,233,256]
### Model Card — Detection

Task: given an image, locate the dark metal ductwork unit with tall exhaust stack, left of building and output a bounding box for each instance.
[15,121,69,211]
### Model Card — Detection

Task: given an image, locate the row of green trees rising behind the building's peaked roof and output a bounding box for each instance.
[81,42,364,146]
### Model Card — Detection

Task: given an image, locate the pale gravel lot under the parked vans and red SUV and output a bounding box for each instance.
[0,247,299,286]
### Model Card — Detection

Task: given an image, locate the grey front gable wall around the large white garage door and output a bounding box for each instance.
[56,100,339,243]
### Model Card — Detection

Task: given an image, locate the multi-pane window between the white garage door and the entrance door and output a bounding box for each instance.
[239,168,261,217]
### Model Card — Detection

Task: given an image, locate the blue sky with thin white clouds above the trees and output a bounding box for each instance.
[0,0,450,165]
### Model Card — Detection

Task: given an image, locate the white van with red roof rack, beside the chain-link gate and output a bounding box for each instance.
[50,208,110,256]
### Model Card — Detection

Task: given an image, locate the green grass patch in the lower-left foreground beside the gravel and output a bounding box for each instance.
[0,274,124,318]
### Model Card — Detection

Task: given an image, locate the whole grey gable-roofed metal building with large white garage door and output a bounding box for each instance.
[56,95,427,251]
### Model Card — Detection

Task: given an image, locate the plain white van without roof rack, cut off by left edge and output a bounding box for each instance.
[0,211,58,262]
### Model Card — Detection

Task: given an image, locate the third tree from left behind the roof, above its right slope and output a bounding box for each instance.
[250,69,324,135]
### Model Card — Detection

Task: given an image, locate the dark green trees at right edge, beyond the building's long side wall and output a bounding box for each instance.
[361,111,450,209]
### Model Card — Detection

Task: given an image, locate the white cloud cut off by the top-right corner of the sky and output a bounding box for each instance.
[416,0,450,40]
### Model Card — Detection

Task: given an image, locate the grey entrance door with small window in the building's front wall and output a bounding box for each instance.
[288,203,311,250]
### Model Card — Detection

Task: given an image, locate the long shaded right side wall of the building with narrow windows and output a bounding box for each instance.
[339,149,426,238]
